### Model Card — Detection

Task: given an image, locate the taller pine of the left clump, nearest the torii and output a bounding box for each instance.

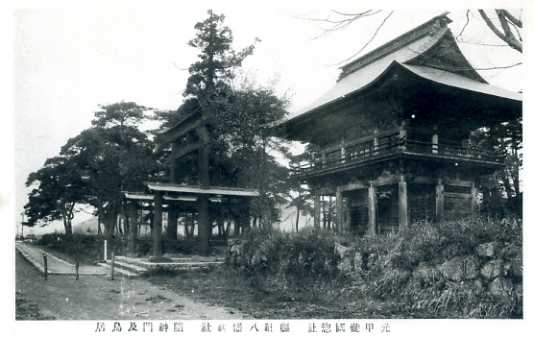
[61,102,161,235]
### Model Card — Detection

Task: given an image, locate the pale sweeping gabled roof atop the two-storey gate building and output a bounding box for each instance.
[284,14,521,125]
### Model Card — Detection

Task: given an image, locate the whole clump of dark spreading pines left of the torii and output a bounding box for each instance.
[25,102,161,236]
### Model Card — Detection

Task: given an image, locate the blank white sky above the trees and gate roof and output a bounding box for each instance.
[10,0,524,235]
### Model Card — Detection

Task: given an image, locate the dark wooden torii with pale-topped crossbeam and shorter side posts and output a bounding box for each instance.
[125,102,259,257]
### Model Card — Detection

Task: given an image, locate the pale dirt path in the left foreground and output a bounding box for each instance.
[16,253,243,320]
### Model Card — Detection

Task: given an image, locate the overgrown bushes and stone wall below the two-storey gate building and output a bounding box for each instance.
[227,219,523,318]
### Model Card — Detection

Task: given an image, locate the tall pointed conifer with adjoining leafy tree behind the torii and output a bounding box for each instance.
[156,10,289,225]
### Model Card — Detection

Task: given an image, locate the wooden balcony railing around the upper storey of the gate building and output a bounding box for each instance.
[290,131,502,176]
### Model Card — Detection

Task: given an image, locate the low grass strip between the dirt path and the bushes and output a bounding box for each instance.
[148,266,399,319]
